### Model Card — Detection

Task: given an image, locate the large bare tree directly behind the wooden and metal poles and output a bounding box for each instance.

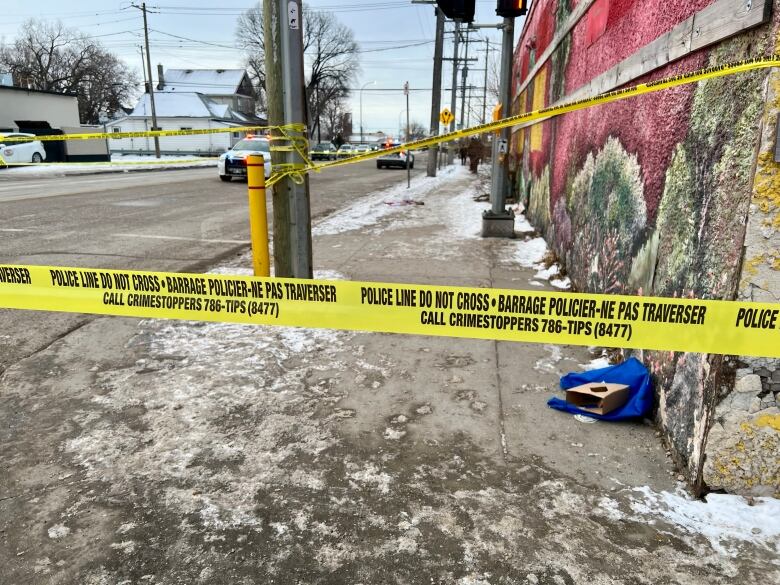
[236,3,360,131]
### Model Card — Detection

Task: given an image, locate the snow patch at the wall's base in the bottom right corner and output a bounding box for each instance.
[631,486,780,557]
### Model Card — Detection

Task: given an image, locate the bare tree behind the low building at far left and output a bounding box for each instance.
[0,19,138,124]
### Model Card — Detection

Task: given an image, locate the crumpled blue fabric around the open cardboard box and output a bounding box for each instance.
[547,357,653,420]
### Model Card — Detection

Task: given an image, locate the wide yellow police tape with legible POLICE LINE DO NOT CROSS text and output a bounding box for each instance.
[0,266,780,358]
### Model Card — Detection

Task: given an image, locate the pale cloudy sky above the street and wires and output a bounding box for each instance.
[0,0,522,135]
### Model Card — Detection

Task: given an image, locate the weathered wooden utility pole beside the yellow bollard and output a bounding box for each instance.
[263,0,293,277]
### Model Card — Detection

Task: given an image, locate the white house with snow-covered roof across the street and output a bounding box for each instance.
[106,67,267,155]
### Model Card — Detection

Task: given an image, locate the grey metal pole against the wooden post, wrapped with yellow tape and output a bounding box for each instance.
[278,0,313,278]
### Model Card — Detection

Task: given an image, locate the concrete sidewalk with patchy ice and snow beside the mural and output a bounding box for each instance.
[0,162,780,585]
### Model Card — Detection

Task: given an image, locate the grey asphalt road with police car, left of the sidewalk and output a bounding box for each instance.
[0,155,425,372]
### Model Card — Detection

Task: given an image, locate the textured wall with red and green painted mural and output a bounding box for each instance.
[512,0,780,493]
